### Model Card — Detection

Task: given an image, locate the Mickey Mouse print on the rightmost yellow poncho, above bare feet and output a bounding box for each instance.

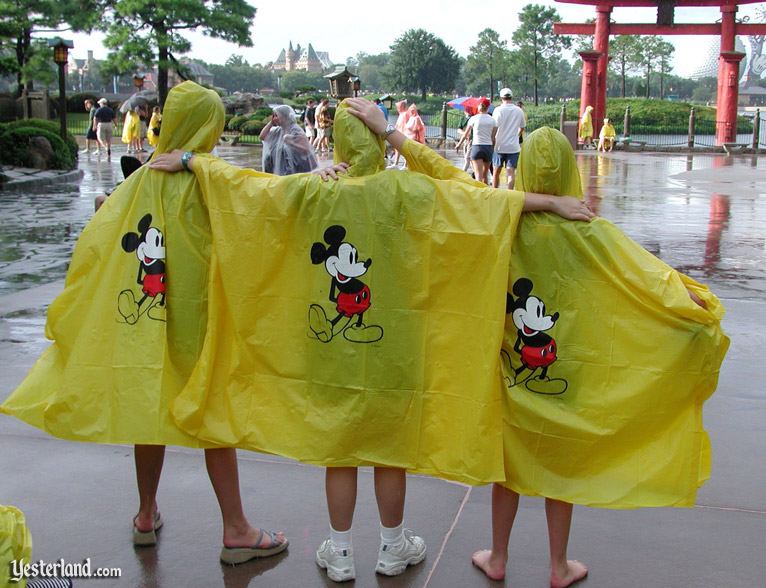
[501,278,568,395]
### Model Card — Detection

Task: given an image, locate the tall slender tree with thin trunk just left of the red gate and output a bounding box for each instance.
[513,4,572,106]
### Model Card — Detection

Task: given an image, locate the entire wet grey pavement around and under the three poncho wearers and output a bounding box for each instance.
[0,147,766,588]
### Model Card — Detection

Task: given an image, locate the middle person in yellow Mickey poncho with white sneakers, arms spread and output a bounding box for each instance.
[151,89,590,581]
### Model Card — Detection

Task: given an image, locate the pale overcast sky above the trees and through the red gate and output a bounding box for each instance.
[63,0,766,76]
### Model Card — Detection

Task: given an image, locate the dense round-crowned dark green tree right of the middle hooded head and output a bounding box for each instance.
[388,29,460,100]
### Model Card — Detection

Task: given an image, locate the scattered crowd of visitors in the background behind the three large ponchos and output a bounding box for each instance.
[82,88,616,181]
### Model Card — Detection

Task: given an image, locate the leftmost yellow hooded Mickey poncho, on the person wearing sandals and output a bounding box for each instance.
[0,82,224,447]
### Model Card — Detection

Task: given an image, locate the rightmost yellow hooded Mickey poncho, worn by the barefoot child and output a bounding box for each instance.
[503,128,729,507]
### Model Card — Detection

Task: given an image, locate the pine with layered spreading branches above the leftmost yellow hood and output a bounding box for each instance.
[99,0,256,103]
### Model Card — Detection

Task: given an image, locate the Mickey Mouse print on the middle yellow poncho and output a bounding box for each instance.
[309,225,383,343]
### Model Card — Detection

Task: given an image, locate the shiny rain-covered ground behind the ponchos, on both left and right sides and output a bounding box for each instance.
[0,147,766,299]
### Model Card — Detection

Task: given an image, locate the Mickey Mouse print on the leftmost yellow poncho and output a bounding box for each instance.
[117,214,165,325]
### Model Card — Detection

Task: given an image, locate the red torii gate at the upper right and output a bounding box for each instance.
[553,0,766,145]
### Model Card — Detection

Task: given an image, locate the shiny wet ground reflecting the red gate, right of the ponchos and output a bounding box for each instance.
[578,153,766,299]
